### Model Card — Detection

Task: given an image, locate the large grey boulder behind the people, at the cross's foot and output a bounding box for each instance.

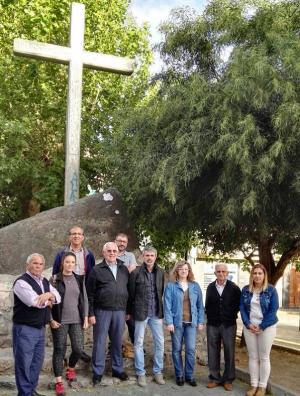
[0,189,137,275]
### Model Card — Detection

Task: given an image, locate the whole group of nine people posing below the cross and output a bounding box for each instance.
[13,226,278,396]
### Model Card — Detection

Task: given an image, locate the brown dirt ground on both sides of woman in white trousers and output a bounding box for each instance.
[236,346,300,395]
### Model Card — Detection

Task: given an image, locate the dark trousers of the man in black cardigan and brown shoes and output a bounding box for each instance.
[207,325,236,384]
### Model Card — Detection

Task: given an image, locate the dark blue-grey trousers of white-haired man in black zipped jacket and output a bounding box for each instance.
[92,309,125,375]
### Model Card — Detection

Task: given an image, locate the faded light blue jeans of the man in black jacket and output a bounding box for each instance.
[134,316,164,375]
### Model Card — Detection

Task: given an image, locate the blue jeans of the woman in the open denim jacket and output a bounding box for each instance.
[171,323,197,380]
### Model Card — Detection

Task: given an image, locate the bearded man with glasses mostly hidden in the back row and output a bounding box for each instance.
[115,232,137,345]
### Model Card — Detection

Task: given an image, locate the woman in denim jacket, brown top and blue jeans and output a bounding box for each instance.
[164,261,204,386]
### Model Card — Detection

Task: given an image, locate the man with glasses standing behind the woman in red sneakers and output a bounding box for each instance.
[52,226,95,279]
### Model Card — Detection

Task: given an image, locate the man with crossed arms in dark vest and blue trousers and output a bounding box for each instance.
[13,253,61,396]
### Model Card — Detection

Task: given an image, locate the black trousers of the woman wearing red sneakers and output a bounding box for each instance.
[51,323,83,377]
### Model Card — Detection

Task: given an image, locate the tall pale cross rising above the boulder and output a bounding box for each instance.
[14,3,134,205]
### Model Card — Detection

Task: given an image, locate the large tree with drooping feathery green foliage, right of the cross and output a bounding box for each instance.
[110,0,300,284]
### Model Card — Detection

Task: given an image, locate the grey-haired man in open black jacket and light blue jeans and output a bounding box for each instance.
[129,247,165,386]
